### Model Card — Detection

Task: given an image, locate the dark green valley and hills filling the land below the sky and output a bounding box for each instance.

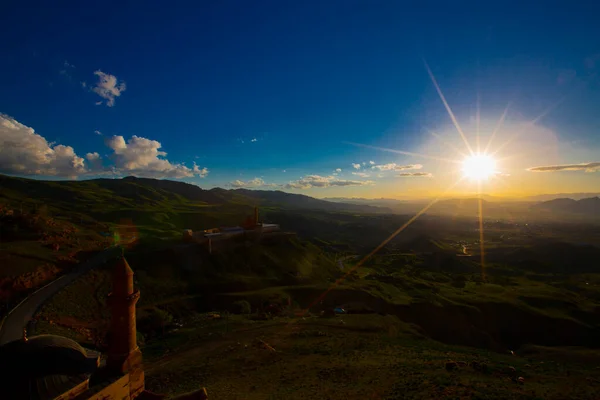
[0,174,600,399]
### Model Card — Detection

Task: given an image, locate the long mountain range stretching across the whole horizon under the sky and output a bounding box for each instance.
[0,175,600,223]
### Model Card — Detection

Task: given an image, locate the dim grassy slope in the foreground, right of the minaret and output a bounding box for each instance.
[139,315,600,399]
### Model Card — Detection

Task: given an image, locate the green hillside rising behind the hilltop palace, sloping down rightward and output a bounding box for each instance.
[0,175,394,245]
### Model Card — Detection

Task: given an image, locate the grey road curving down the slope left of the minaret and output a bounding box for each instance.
[0,247,118,346]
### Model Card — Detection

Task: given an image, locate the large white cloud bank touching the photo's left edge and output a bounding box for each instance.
[0,114,85,177]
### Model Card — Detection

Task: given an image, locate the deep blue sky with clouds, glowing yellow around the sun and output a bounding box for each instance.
[0,0,600,197]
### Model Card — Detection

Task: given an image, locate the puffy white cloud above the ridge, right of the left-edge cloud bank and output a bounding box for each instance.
[106,136,209,178]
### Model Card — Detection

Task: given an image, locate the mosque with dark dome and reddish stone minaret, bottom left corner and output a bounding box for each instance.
[0,257,207,400]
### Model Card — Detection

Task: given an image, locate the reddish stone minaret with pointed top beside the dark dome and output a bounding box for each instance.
[106,257,144,398]
